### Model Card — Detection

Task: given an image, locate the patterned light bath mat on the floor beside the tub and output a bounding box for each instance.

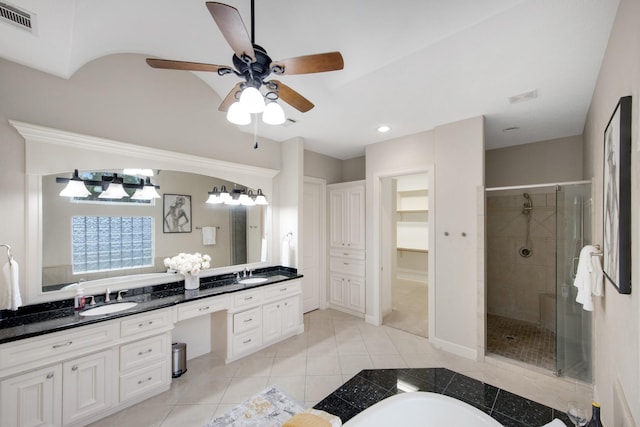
[204,387,305,427]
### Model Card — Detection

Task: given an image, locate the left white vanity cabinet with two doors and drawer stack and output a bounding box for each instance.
[0,309,173,427]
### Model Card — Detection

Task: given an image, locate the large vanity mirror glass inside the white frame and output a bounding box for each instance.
[41,170,267,292]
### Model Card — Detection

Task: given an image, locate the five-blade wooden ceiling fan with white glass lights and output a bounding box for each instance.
[147,0,344,124]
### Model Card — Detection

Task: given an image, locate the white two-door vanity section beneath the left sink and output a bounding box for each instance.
[0,324,117,427]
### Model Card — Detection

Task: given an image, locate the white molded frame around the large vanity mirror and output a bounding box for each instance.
[9,120,279,304]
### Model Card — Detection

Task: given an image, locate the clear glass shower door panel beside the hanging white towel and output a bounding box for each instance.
[556,182,593,383]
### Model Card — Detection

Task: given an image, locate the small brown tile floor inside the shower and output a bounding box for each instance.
[487,314,556,371]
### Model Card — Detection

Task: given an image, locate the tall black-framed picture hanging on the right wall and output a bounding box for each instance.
[602,96,632,294]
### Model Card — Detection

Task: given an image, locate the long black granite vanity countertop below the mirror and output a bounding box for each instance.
[0,267,302,344]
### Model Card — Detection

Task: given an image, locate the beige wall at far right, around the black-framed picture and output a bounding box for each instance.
[583,0,640,426]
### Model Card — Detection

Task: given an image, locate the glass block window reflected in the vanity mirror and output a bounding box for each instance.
[71,216,153,274]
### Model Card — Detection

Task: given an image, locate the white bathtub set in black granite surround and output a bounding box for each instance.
[344,391,502,427]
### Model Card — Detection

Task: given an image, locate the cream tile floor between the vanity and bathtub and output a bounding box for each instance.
[92,310,592,427]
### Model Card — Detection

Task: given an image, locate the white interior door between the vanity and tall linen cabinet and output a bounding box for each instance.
[302,177,326,313]
